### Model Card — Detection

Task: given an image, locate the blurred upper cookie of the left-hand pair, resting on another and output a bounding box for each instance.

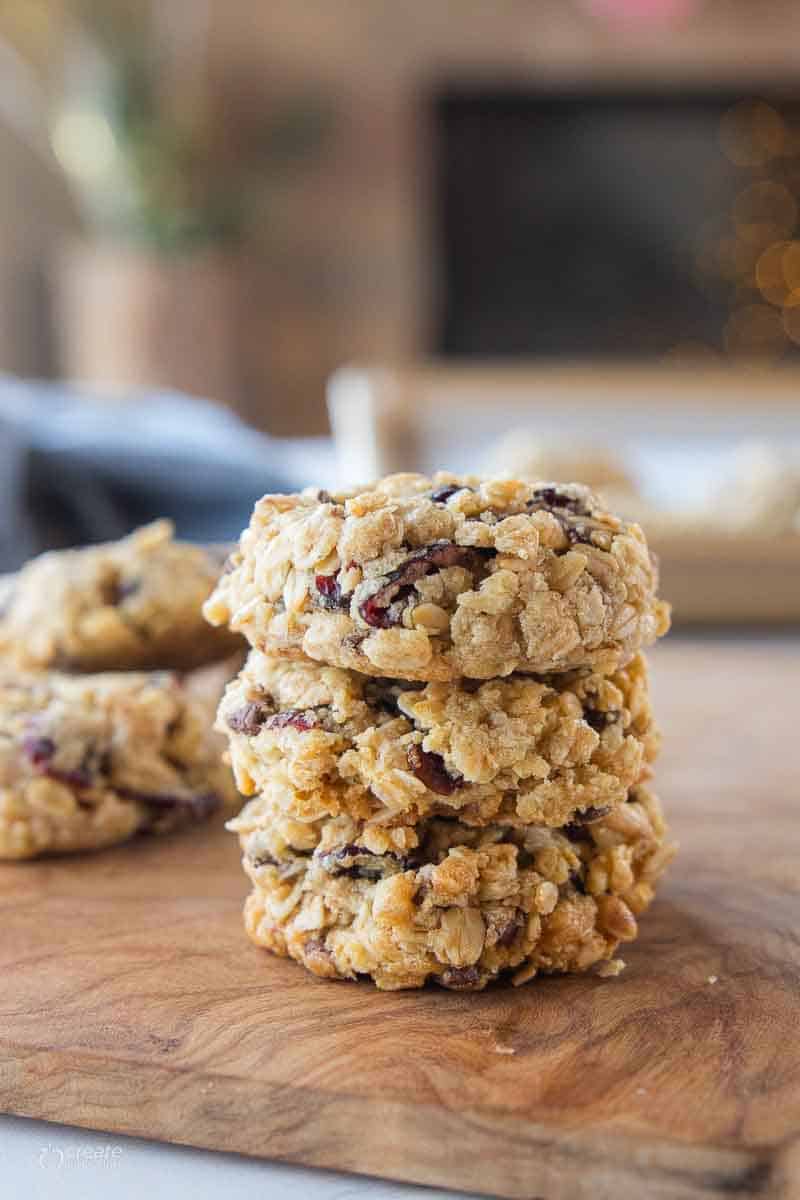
[0,521,241,671]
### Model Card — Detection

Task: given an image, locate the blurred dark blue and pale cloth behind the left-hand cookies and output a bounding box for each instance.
[0,378,332,571]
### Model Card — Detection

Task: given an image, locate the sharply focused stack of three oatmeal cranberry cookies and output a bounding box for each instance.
[205,474,672,990]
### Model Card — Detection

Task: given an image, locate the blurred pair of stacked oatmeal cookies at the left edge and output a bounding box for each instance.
[0,521,241,859]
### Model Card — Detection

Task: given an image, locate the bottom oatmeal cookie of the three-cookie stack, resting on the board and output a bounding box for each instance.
[230,786,674,990]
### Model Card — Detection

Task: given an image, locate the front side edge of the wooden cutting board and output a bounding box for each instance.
[0,1038,800,1200]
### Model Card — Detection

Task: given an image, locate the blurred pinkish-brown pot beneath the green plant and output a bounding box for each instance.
[54,242,241,407]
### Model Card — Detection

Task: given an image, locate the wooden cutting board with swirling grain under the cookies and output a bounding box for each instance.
[0,640,800,1200]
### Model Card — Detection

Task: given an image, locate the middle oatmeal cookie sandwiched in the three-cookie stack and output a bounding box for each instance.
[217,650,658,826]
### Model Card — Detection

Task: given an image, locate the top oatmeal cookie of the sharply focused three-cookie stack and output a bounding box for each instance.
[205,474,669,680]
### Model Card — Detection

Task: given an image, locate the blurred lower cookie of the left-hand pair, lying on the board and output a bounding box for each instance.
[0,668,235,858]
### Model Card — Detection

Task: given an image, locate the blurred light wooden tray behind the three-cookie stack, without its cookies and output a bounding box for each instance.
[327,361,800,624]
